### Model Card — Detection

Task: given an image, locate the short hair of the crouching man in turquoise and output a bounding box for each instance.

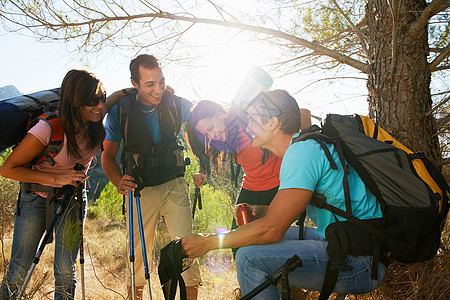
[249,90,302,134]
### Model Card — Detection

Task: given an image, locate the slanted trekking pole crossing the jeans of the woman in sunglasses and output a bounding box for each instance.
[16,185,75,300]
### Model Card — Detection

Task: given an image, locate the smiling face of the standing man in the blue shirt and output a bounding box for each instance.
[131,66,166,106]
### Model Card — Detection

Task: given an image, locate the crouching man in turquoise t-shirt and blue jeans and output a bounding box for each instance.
[182,90,386,299]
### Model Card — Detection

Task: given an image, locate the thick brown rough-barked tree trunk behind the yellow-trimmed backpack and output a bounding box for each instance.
[366,0,441,161]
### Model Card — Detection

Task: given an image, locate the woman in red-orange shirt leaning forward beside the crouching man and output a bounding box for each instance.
[185,100,311,253]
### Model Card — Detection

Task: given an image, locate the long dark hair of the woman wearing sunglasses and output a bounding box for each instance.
[58,70,105,158]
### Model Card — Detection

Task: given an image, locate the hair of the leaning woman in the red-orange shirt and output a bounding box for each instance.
[184,100,245,173]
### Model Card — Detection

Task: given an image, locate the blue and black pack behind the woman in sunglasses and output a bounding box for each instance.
[0,88,59,151]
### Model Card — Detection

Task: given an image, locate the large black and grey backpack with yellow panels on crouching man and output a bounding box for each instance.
[292,114,450,299]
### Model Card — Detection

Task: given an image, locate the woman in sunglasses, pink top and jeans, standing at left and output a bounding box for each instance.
[0,70,118,299]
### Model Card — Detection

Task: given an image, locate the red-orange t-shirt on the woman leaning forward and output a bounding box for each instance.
[237,129,281,191]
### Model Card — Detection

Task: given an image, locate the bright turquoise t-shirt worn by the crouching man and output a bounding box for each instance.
[279,136,382,238]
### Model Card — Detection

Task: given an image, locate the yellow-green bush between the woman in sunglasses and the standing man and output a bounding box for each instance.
[88,182,125,221]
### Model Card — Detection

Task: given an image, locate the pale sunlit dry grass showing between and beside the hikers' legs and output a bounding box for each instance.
[0,219,238,300]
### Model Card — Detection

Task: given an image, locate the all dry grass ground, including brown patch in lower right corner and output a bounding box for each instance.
[2,211,450,300]
